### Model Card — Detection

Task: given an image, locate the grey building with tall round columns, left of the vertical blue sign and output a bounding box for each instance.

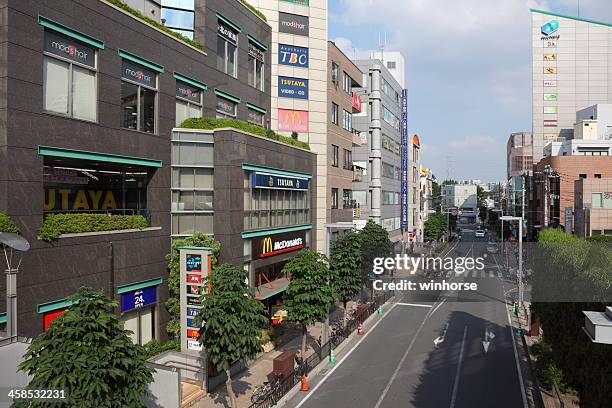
[353,59,404,241]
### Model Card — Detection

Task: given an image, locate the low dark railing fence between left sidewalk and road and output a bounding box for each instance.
[249,292,393,408]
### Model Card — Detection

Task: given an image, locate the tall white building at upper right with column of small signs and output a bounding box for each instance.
[531,9,612,163]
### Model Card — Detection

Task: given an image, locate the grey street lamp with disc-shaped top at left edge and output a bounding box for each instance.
[0,232,30,338]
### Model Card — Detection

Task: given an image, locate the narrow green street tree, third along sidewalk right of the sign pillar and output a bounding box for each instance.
[329,231,363,327]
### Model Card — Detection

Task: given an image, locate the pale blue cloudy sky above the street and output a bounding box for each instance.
[329,0,612,181]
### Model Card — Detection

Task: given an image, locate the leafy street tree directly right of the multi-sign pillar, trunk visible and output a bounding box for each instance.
[198,264,267,408]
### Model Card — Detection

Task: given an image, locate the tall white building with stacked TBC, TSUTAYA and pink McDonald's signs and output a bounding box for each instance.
[249,0,330,251]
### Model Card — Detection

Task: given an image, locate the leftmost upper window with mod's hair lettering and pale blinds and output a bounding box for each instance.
[43,31,97,122]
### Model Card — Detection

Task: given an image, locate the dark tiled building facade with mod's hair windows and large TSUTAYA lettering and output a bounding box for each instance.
[0,0,271,344]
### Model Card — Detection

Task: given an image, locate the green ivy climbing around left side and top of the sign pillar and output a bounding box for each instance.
[166,232,221,343]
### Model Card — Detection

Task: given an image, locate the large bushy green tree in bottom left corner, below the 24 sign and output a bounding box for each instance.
[14,288,153,408]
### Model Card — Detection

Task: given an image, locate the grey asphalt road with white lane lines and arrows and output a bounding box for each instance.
[289,225,526,408]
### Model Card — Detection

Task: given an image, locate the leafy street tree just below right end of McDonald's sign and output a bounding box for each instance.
[283,250,336,358]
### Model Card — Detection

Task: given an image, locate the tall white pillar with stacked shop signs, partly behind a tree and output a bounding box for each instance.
[179,247,211,356]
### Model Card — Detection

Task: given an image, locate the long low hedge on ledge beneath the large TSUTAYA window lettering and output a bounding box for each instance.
[38,214,149,241]
